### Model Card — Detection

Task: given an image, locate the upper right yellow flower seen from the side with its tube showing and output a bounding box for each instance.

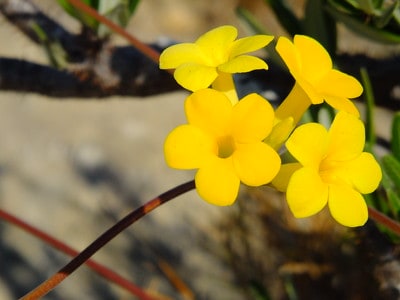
[276,35,363,124]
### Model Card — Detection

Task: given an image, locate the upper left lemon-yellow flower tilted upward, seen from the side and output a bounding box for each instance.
[160,25,273,91]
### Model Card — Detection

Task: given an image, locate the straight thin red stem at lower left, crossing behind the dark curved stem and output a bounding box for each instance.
[0,209,158,300]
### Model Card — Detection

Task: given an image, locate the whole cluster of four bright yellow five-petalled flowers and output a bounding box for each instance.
[160,26,382,227]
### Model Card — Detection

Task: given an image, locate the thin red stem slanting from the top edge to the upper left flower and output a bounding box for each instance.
[68,0,160,64]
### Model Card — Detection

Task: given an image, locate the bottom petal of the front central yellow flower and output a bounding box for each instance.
[195,157,240,206]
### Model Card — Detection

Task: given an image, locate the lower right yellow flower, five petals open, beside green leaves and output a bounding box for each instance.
[272,111,382,227]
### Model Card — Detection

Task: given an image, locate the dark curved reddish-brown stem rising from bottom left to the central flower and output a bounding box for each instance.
[21,180,195,300]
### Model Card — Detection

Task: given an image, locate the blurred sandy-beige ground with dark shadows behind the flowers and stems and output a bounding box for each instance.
[0,0,400,300]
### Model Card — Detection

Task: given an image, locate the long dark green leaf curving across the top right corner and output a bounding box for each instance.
[326,6,400,44]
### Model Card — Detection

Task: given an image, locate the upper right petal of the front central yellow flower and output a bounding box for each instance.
[232,93,274,143]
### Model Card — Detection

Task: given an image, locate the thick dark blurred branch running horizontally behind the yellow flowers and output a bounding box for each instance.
[0,0,400,105]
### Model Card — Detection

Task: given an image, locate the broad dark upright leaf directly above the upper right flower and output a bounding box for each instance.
[303,0,336,57]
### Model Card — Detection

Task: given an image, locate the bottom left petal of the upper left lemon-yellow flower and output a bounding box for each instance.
[174,63,218,92]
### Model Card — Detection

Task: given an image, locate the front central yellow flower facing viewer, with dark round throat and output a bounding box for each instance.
[164,89,280,205]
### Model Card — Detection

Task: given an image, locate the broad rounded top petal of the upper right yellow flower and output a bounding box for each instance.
[293,35,332,84]
